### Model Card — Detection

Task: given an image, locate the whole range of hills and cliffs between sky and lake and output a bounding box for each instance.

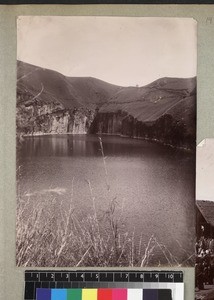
[17,62,196,148]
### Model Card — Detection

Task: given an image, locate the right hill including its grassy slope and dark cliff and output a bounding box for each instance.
[91,78,196,148]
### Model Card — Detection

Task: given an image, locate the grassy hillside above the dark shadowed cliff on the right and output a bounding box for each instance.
[100,78,195,122]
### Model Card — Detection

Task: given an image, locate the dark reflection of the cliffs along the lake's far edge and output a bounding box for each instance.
[21,135,187,159]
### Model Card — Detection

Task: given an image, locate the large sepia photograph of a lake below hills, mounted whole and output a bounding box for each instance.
[16,16,197,267]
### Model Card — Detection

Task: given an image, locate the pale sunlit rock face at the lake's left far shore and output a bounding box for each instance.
[17,96,95,135]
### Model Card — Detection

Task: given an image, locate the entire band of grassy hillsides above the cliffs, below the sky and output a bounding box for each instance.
[17,61,196,125]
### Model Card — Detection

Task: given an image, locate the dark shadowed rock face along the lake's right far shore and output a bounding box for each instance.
[90,111,195,149]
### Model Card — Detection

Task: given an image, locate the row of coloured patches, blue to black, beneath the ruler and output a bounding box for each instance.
[36,288,172,300]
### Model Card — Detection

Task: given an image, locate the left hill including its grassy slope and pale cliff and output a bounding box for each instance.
[17,61,120,135]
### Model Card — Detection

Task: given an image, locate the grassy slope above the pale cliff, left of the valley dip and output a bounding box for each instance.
[17,61,120,108]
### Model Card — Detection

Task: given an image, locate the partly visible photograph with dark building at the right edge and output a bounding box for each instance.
[195,138,214,300]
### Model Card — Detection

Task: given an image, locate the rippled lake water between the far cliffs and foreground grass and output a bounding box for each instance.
[17,135,195,262]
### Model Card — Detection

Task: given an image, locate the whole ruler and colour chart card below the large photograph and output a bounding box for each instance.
[24,270,184,300]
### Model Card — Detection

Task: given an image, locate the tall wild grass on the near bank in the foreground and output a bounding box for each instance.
[16,138,194,267]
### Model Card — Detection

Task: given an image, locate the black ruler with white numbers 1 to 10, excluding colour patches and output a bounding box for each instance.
[24,270,183,300]
